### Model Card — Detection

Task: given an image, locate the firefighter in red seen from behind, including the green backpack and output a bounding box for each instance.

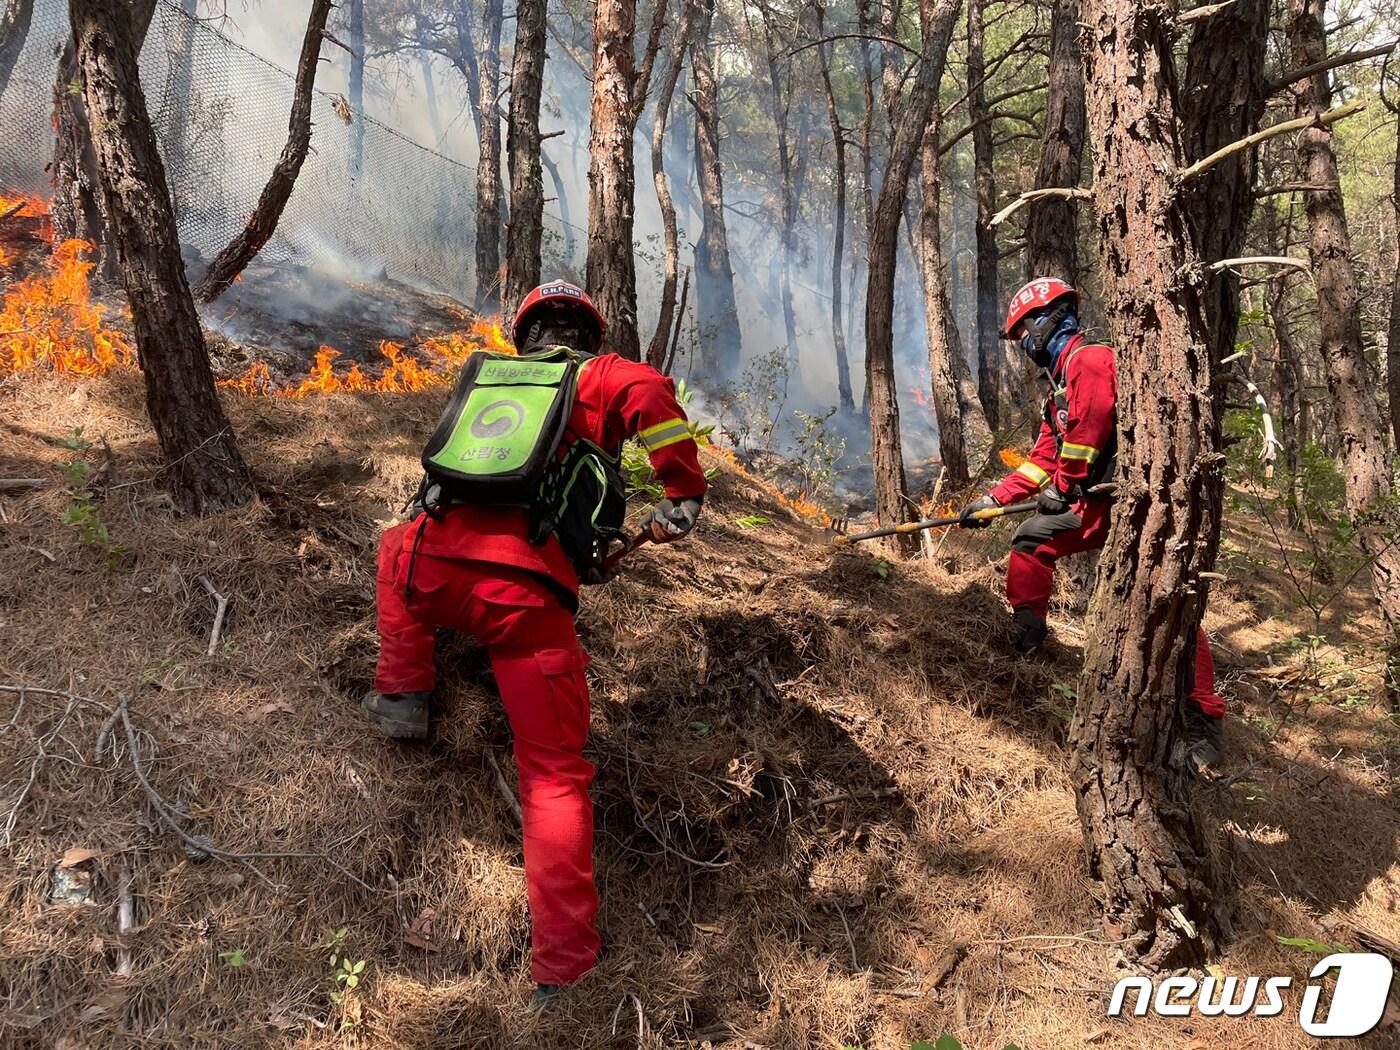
[364,281,706,1007]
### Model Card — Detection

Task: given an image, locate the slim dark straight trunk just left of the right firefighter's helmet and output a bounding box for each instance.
[967,0,1005,430]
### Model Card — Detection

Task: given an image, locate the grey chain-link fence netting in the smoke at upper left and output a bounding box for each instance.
[0,0,610,310]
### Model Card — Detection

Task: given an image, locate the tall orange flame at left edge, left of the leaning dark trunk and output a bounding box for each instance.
[0,241,134,377]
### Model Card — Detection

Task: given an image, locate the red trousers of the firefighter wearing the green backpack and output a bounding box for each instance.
[374,525,598,984]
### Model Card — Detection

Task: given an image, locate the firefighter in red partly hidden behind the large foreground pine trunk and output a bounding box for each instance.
[960,277,1225,769]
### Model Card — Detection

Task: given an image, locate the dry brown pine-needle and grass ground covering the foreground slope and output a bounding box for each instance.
[0,375,1400,1050]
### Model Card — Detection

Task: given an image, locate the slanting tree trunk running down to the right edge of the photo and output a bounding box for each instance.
[1288,0,1400,638]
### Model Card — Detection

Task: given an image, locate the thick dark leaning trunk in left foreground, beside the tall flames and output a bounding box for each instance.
[69,0,253,512]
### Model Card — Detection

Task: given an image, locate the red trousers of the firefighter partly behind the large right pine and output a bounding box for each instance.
[1007,500,1225,718]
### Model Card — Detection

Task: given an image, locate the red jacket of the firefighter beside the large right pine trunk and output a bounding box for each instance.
[991,335,1119,505]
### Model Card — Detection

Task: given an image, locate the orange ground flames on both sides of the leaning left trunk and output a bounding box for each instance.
[0,233,515,398]
